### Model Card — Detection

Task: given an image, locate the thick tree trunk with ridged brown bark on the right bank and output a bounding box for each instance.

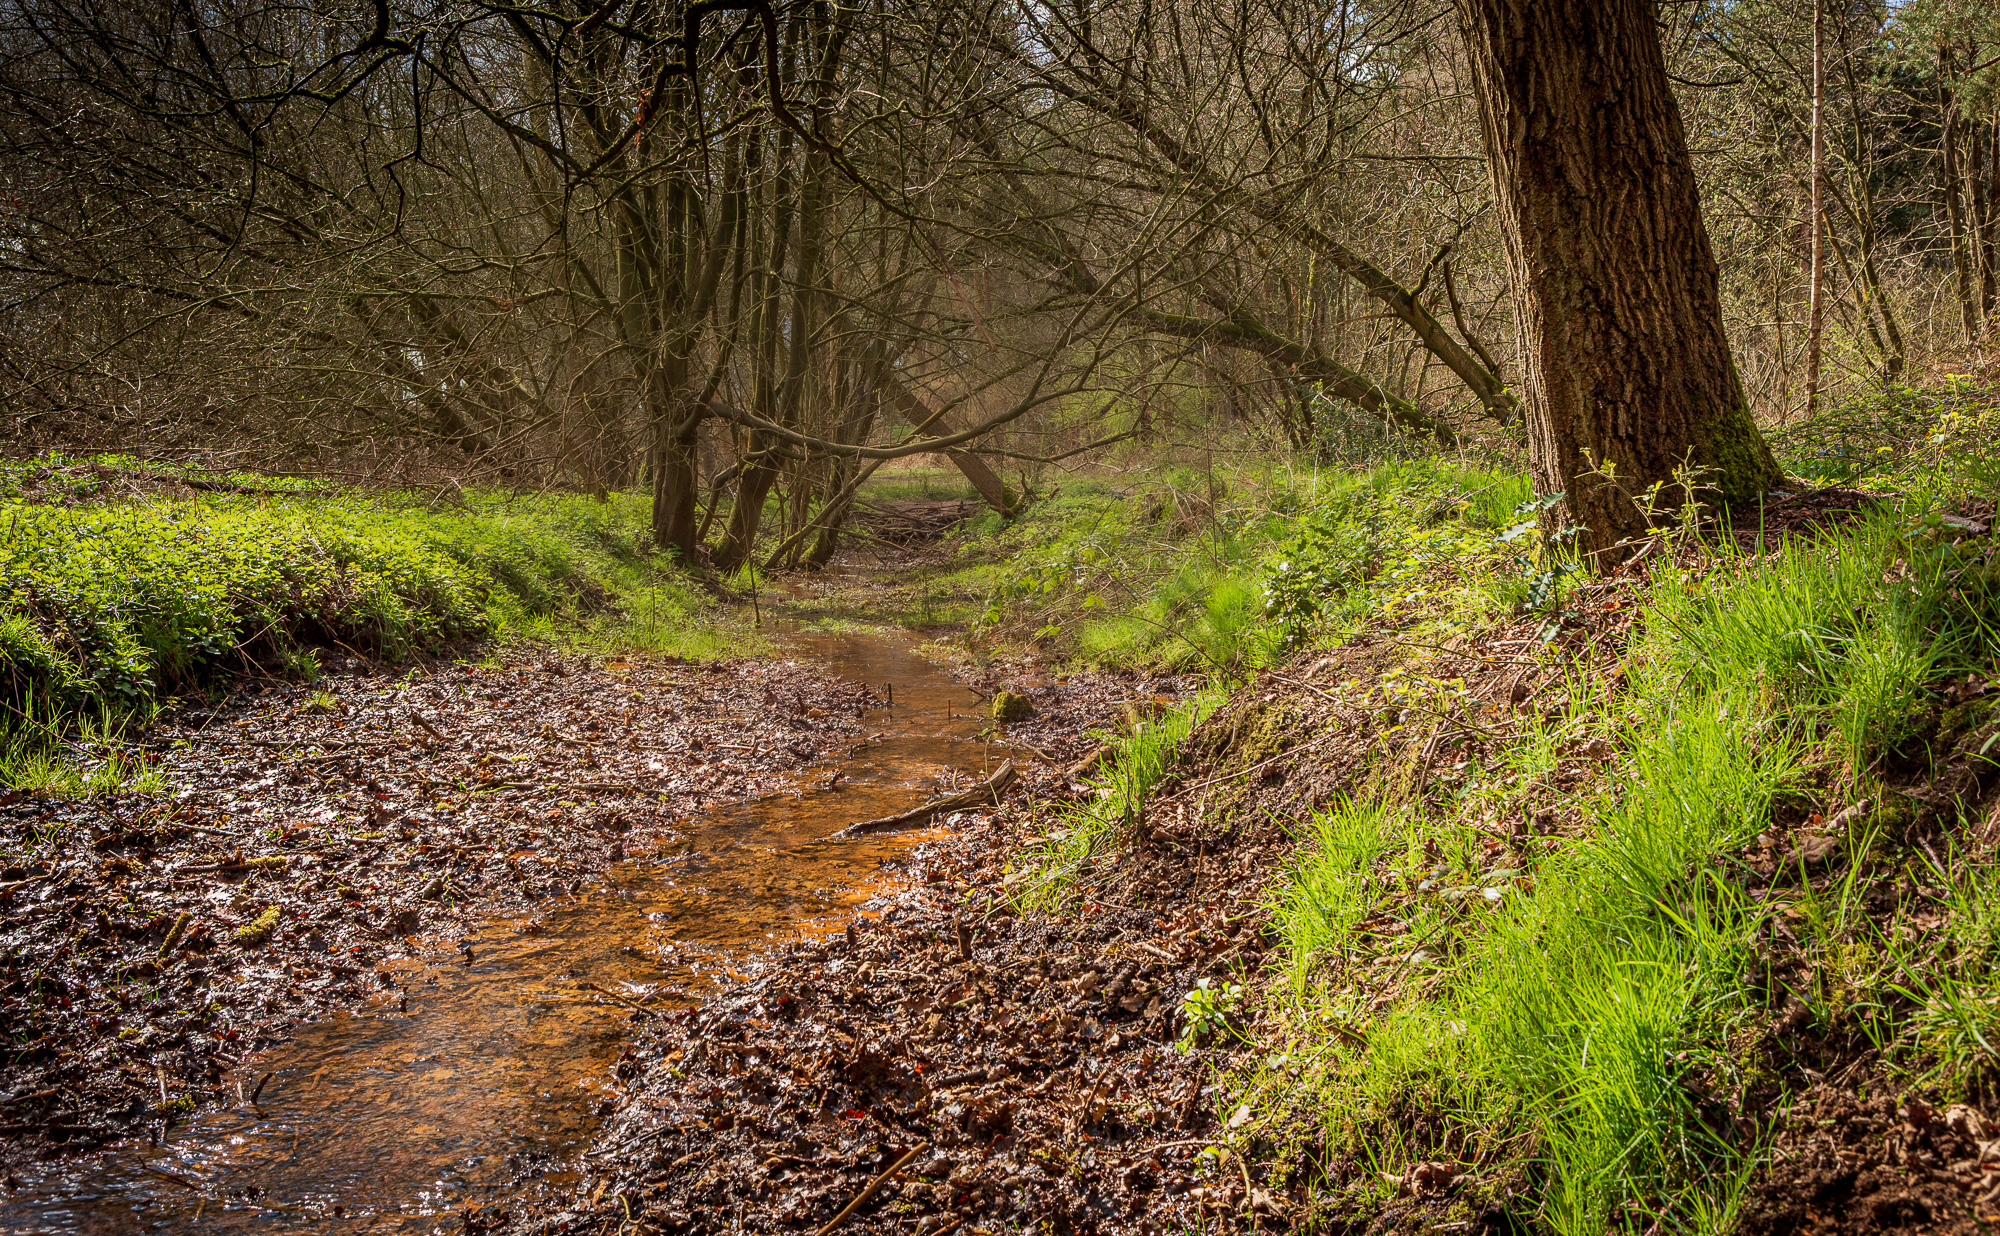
[1454,0,1780,568]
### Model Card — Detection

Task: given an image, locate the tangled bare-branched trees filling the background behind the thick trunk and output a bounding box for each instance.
[0,0,2000,568]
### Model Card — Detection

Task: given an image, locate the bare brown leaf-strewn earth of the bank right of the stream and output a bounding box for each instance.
[508,522,2000,1236]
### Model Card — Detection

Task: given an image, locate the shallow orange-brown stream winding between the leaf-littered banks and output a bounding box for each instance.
[0,632,1002,1234]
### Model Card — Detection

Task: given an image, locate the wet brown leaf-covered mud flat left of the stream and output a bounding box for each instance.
[0,650,868,1164]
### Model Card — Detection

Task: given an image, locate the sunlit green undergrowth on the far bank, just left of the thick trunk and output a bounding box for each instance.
[952,460,1528,682]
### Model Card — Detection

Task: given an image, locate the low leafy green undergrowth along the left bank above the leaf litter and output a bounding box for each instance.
[0,460,746,784]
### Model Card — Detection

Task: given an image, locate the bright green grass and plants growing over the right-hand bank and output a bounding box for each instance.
[984,386,2000,1236]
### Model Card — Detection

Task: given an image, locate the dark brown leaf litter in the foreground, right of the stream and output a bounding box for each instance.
[516,800,1278,1234]
